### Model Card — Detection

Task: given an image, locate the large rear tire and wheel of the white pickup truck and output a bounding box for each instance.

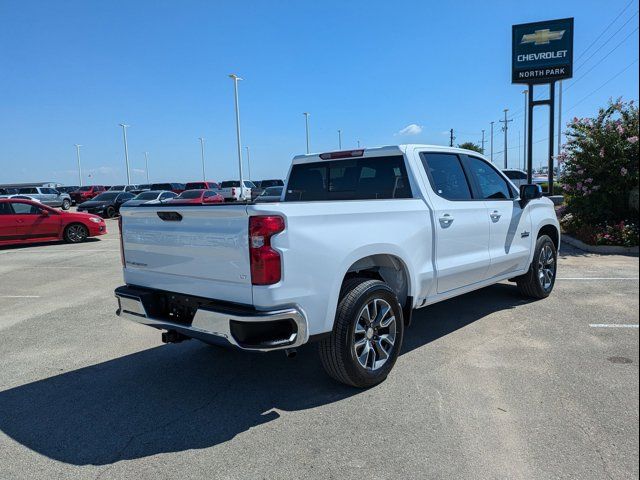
[319,278,404,388]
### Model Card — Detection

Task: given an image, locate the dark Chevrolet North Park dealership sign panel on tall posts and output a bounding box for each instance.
[511,18,573,84]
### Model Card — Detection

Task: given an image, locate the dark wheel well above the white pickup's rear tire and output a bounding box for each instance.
[342,254,409,307]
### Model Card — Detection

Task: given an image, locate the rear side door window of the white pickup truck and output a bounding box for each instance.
[420,153,472,200]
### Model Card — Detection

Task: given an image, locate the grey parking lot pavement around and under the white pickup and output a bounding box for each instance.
[0,230,638,479]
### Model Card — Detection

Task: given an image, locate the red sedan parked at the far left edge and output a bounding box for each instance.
[0,198,107,245]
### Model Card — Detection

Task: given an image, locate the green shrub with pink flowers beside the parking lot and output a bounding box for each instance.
[559,100,640,245]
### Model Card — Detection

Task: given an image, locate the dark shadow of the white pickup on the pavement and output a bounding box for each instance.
[0,284,523,465]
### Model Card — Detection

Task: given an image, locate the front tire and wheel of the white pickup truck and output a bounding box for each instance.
[516,235,558,299]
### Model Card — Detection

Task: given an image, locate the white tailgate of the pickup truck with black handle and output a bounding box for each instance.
[121,205,252,304]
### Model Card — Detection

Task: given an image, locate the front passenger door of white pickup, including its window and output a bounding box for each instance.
[464,156,532,277]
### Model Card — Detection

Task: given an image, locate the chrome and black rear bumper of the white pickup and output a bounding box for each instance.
[115,286,309,352]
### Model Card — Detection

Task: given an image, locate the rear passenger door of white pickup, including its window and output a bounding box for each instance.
[420,152,491,293]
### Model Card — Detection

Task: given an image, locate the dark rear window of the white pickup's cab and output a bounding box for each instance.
[285,155,412,202]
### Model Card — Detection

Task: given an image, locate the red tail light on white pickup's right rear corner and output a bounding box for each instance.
[249,216,284,285]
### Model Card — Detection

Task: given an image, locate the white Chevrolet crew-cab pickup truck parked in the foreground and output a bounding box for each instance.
[115,145,560,387]
